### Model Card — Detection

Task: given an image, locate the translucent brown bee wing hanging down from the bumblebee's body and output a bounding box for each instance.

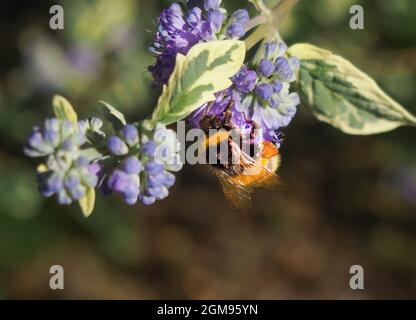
[213,168,253,213]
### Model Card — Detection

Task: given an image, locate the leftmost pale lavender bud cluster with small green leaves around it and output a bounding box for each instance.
[24,118,102,204]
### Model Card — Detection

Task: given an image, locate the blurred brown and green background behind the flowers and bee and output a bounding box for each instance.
[0,0,416,299]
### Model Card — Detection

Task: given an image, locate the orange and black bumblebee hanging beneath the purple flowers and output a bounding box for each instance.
[200,105,280,213]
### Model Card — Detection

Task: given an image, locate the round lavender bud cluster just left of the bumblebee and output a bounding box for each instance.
[102,124,182,205]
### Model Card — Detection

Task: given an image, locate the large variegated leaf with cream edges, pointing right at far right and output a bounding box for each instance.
[288,44,416,135]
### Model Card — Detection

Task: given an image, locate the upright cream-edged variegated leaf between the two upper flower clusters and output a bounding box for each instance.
[152,40,246,125]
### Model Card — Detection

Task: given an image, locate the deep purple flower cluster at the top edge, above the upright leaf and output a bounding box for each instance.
[149,0,249,86]
